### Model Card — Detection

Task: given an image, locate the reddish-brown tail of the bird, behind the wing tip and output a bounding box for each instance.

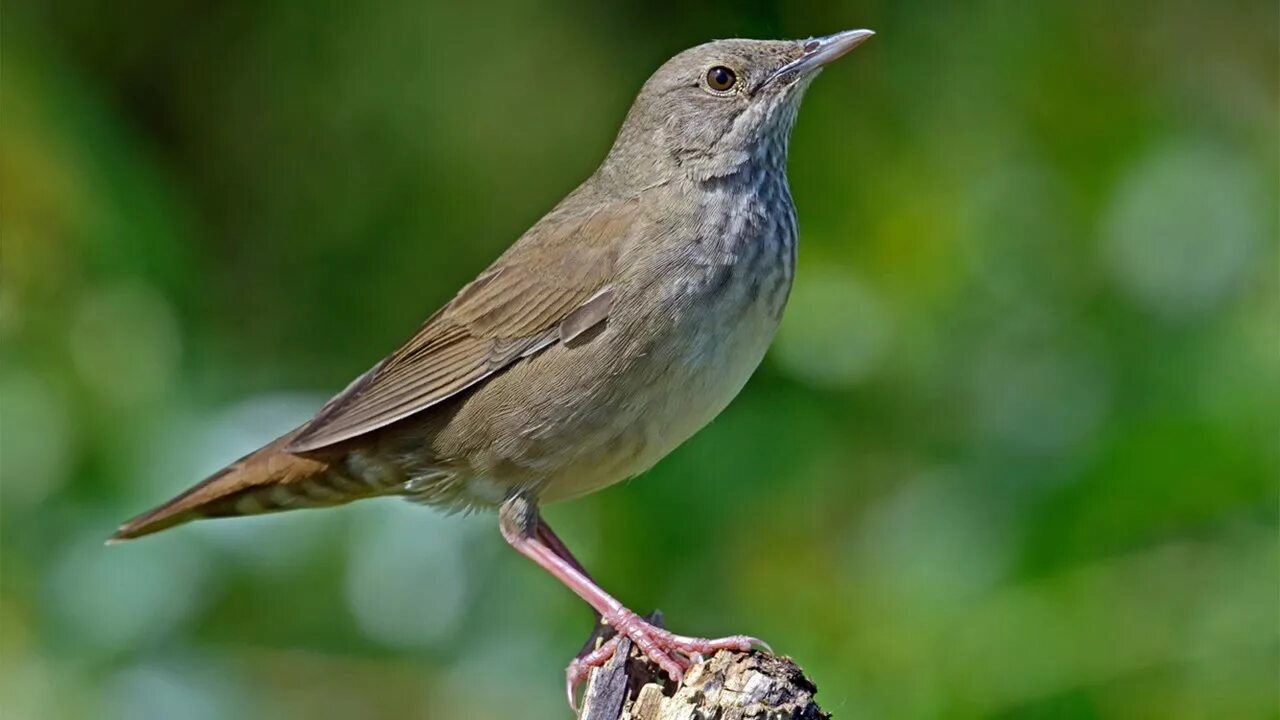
[109,425,387,542]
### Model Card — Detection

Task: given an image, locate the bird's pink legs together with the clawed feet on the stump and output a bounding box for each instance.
[498,493,767,705]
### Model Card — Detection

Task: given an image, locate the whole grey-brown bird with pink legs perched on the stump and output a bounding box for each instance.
[111,29,874,705]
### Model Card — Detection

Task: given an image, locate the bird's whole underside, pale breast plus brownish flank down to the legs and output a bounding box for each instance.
[424,167,796,505]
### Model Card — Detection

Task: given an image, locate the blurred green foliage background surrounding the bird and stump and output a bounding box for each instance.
[0,0,1280,720]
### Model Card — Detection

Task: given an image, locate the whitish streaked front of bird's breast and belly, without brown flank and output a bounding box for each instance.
[532,174,796,501]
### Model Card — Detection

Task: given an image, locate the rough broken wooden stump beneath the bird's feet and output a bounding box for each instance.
[579,617,831,720]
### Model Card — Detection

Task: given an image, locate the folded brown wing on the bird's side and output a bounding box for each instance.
[288,200,636,452]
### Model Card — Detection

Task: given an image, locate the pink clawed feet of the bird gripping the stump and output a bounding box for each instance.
[564,609,772,706]
